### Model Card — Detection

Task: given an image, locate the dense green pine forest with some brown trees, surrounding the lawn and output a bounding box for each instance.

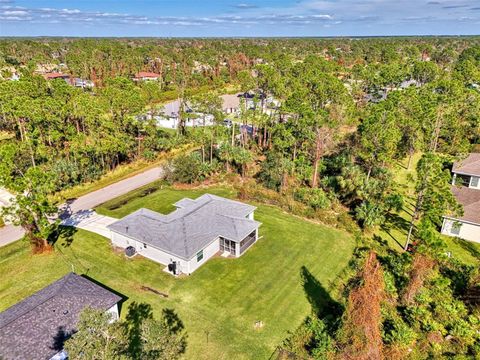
[0,37,480,359]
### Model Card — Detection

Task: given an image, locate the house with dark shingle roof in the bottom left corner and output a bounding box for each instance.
[0,273,121,360]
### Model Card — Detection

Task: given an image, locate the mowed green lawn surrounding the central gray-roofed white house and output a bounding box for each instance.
[0,188,355,359]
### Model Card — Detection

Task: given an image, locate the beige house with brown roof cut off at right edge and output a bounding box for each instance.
[442,153,480,242]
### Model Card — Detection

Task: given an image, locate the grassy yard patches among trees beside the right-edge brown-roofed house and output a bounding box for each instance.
[373,153,480,265]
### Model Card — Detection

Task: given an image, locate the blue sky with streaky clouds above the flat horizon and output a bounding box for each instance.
[0,0,480,37]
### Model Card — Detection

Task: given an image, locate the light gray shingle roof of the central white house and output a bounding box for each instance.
[108,194,260,260]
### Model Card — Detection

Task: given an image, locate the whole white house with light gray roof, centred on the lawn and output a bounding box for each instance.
[108,194,260,274]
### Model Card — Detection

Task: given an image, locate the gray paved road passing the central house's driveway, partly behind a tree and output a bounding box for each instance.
[0,166,164,246]
